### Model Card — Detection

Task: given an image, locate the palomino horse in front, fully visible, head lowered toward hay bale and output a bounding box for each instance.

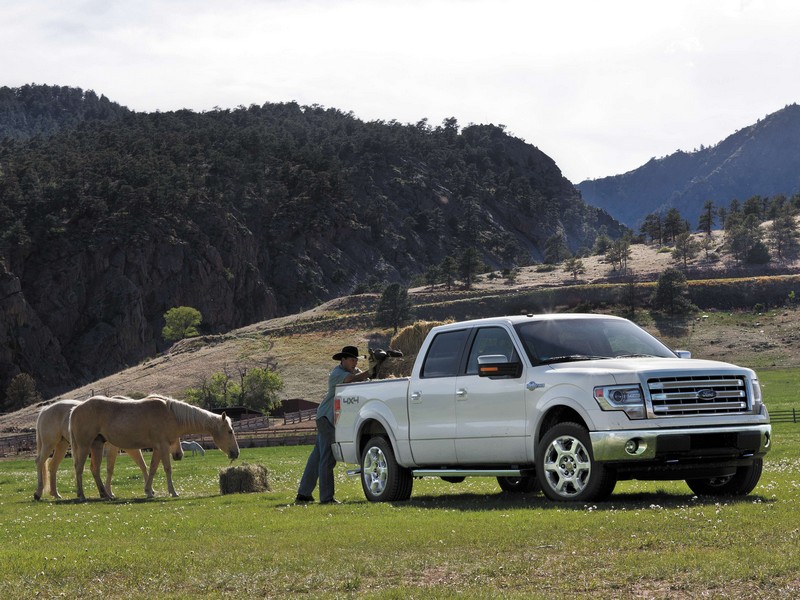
[69,395,239,500]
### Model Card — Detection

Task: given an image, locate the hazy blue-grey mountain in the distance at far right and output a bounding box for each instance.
[578,104,800,229]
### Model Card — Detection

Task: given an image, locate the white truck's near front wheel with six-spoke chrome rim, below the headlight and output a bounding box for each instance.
[536,423,617,502]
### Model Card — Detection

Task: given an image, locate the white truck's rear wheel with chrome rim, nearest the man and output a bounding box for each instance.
[361,436,414,502]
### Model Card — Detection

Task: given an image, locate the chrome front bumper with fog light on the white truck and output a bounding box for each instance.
[589,424,772,463]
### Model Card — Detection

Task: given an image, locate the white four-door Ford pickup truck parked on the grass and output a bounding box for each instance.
[333,314,771,502]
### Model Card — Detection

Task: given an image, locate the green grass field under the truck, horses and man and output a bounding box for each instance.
[0,371,800,599]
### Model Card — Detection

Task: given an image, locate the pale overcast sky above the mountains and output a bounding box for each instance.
[0,0,800,183]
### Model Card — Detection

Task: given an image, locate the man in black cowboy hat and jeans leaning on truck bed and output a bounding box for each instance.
[295,346,369,504]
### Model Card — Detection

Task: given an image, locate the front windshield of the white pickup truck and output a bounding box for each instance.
[515,319,675,365]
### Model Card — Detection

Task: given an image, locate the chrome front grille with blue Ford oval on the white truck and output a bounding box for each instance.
[647,375,749,417]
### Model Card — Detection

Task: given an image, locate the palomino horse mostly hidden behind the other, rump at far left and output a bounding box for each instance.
[33,400,152,500]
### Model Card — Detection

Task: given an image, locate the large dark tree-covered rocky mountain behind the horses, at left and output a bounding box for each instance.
[0,86,624,404]
